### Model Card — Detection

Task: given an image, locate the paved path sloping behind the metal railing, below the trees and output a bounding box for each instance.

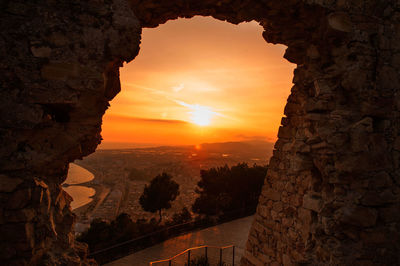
[106,216,253,266]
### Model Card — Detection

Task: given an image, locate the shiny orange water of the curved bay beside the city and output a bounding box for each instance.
[64,163,96,210]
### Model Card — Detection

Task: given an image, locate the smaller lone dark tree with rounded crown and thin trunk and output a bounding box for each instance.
[139,173,179,222]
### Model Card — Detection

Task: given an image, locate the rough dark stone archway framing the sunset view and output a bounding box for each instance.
[0,0,400,265]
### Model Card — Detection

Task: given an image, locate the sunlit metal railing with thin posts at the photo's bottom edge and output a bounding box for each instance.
[150,245,235,266]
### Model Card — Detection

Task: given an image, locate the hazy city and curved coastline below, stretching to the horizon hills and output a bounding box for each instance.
[63,141,273,233]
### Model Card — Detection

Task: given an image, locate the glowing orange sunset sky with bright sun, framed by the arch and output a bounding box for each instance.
[102,17,295,148]
